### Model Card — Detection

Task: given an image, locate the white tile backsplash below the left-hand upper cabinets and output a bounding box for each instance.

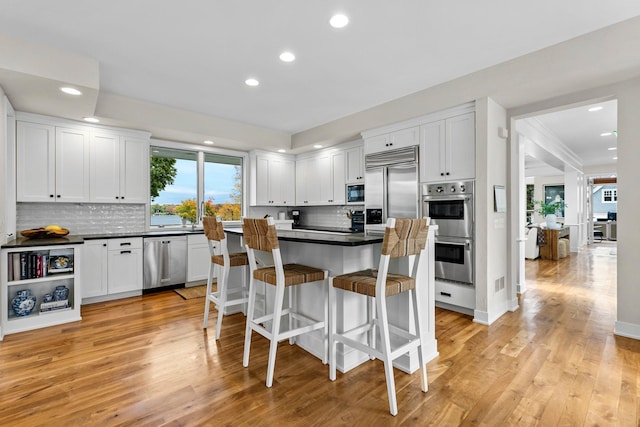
[16,203,147,234]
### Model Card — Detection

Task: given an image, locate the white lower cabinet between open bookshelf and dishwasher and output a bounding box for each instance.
[82,237,143,303]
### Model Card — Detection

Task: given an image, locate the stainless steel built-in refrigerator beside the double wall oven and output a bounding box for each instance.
[364,146,420,232]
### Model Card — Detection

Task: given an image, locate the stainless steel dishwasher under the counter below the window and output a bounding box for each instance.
[142,236,187,293]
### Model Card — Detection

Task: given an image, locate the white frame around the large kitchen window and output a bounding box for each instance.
[145,139,249,230]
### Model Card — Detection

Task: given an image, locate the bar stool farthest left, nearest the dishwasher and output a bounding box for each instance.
[202,216,249,340]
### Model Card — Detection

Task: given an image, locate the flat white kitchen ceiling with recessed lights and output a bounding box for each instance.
[0,0,640,157]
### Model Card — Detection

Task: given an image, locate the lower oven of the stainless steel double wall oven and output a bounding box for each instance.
[435,237,474,285]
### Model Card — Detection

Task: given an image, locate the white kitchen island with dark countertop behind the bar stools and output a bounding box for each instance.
[225,226,438,373]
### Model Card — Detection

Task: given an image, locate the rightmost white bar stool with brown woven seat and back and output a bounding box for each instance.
[329,218,429,416]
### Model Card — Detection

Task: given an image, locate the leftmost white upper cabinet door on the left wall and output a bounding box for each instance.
[16,122,56,202]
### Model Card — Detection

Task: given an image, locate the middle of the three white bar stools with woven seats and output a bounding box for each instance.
[242,217,328,387]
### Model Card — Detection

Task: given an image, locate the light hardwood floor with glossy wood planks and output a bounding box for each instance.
[0,244,640,426]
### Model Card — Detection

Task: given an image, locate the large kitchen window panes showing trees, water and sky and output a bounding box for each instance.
[150,146,243,227]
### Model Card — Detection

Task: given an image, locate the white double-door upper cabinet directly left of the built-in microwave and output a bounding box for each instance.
[296,150,346,206]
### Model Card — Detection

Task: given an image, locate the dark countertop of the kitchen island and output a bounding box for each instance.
[224,227,383,246]
